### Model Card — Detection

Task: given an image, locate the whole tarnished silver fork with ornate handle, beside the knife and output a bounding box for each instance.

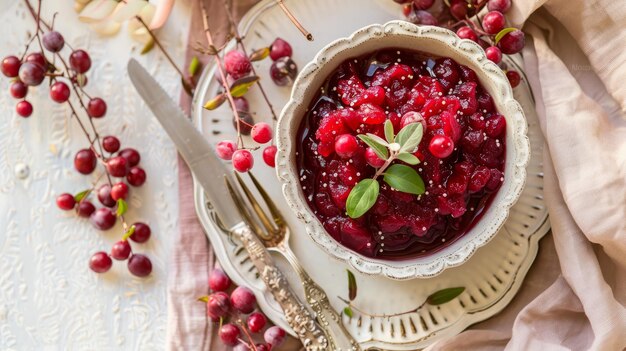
[227,173,361,350]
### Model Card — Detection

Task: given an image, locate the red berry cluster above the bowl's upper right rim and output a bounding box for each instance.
[394,0,524,88]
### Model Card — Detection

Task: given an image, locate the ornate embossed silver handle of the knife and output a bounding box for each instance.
[232,224,331,351]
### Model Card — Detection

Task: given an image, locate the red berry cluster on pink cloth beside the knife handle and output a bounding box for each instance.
[200,269,286,351]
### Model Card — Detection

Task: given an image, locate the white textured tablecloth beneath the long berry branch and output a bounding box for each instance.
[0,0,189,350]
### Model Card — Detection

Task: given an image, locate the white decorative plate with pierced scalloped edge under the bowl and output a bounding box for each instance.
[193,0,549,350]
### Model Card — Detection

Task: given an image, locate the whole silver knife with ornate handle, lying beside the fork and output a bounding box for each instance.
[128,59,329,351]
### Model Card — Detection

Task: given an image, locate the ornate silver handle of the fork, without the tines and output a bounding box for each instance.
[274,241,361,350]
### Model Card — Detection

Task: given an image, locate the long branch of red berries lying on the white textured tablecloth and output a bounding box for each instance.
[0,12,152,277]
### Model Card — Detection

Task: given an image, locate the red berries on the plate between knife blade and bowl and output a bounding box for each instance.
[216,38,298,172]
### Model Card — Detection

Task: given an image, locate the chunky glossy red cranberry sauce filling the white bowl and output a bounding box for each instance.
[297,49,506,260]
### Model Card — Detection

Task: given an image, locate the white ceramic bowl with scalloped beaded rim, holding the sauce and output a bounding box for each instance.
[276,21,530,279]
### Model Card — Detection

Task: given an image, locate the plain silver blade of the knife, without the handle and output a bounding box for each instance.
[128,59,243,229]
